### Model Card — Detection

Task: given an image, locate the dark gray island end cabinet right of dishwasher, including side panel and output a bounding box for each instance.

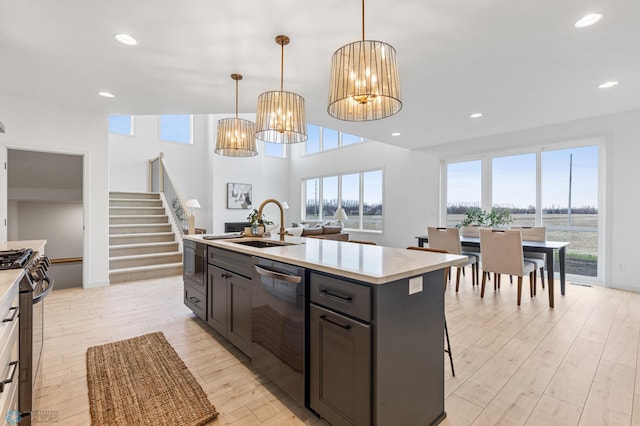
[308,270,446,426]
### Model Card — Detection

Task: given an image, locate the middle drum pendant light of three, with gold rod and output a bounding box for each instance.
[255,35,307,144]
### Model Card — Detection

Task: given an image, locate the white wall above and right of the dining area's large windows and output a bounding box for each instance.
[424,110,640,291]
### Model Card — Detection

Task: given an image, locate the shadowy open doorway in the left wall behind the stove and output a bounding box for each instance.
[7,149,84,289]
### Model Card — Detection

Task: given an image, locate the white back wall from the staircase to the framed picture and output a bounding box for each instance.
[109,114,289,233]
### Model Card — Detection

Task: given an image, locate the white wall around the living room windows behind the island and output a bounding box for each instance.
[289,141,439,248]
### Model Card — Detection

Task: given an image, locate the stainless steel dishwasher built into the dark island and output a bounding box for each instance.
[251,257,308,404]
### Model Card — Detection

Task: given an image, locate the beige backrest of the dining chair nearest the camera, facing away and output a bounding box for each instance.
[480,228,524,277]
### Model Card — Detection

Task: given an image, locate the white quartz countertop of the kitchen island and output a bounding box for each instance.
[183,235,465,284]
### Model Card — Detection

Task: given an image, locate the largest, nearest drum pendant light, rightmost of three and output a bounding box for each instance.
[327,0,402,121]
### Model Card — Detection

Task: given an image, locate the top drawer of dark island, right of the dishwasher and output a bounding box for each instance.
[310,272,371,322]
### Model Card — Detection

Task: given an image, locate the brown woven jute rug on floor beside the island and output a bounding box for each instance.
[87,332,218,426]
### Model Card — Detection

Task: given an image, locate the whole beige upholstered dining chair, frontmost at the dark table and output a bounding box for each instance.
[480,228,536,306]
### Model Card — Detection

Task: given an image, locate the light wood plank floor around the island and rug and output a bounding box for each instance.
[34,274,640,426]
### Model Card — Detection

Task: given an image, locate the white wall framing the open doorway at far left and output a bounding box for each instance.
[0,96,109,287]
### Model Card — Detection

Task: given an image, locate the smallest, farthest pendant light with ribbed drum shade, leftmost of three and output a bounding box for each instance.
[213,74,258,157]
